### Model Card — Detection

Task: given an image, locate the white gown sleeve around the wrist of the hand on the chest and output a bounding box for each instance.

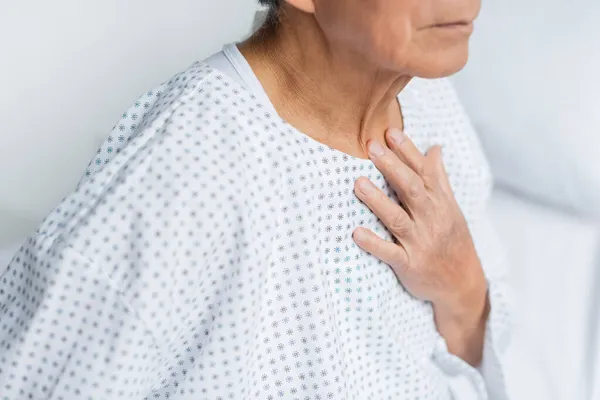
[435,203,514,400]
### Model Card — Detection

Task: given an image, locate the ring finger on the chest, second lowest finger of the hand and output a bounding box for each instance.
[354,176,414,239]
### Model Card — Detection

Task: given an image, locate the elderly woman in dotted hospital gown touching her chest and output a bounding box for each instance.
[0,0,510,400]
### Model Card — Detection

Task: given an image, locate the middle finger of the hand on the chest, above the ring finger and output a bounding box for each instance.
[369,140,427,213]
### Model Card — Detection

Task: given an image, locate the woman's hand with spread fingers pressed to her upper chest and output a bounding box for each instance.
[353,129,489,366]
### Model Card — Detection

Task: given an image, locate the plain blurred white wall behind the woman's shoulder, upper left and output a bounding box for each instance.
[0,0,256,242]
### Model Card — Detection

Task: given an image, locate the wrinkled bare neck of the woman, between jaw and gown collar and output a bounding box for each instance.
[239,10,410,158]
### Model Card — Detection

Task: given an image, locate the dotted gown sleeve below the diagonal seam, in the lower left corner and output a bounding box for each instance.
[0,236,162,400]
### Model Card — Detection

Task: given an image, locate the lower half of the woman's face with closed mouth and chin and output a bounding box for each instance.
[302,0,481,78]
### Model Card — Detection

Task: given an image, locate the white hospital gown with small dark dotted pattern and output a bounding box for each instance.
[0,50,510,400]
